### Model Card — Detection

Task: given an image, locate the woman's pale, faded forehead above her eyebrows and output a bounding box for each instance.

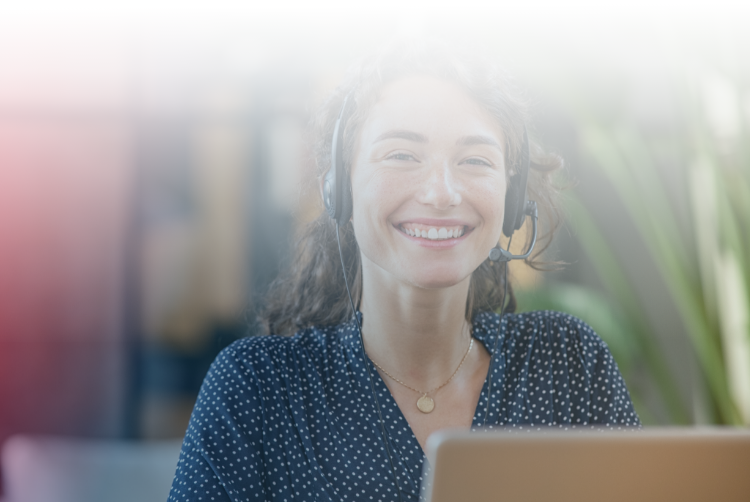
[361,75,504,144]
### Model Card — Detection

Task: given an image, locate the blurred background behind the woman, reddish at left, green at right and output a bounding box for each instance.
[0,1,750,499]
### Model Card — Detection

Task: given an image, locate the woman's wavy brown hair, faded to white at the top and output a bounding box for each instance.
[260,42,562,335]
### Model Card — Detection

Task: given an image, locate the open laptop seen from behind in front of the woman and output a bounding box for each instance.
[422,428,750,501]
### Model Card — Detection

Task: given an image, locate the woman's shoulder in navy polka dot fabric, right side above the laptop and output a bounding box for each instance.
[484,311,640,426]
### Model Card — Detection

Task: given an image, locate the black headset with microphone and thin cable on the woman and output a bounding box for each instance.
[323,93,538,500]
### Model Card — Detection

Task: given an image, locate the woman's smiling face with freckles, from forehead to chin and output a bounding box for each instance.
[351,75,506,288]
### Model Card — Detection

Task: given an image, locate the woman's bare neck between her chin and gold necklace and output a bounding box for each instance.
[360,259,471,391]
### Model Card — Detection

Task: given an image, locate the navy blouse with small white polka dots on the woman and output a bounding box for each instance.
[169,311,639,501]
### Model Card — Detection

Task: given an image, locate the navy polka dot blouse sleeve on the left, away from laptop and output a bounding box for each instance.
[169,340,268,501]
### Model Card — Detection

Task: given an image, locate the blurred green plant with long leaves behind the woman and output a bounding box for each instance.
[521,61,750,425]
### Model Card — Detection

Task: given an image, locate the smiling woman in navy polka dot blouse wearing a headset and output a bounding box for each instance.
[170,41,639,501]
